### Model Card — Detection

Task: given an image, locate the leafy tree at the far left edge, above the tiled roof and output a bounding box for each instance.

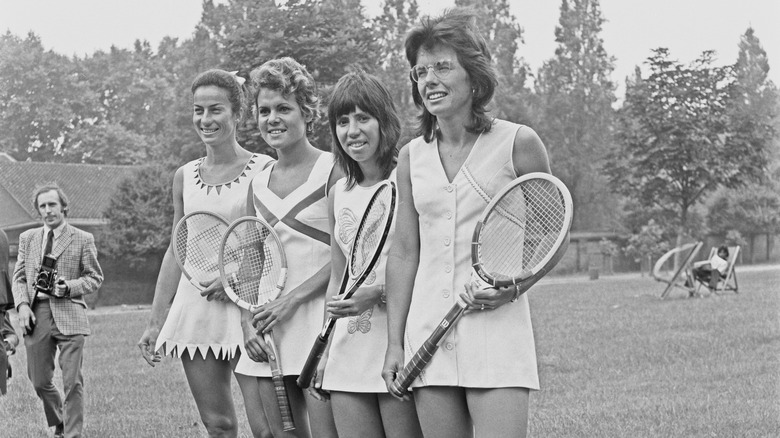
[0,32,95,161]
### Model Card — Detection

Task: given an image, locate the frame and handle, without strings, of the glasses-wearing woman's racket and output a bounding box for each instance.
[390,172,573,396]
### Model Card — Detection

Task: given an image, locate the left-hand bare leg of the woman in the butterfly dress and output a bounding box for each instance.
[330,391,386,438]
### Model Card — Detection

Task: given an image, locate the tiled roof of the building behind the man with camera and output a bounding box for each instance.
[0,161,138,220]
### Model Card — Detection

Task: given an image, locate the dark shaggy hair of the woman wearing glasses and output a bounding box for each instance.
[404,8,498,142]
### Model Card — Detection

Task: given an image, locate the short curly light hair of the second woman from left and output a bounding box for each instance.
[249,56,320,132]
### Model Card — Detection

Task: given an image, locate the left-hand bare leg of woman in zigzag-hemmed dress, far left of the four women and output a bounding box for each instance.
[181,350,238,437]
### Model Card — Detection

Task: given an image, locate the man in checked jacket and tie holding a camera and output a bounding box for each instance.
[13,184,103,437]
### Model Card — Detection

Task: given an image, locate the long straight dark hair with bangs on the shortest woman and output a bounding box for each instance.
[328,71,401,188]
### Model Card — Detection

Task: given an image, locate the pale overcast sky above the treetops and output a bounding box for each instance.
[0,0,780,92]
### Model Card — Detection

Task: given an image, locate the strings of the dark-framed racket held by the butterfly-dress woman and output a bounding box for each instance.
[349,186,392,277]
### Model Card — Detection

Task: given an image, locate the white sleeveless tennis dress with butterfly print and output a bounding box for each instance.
[322,171,395,393]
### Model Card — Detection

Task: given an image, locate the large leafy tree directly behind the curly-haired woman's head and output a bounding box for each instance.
[201,0,378,151]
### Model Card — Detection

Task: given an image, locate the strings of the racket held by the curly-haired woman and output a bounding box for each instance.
[223,221,282,305]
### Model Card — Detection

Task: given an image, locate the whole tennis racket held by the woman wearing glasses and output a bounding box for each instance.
[390,172,572,396]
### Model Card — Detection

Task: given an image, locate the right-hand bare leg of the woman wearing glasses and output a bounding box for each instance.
[466,388,529,438]
